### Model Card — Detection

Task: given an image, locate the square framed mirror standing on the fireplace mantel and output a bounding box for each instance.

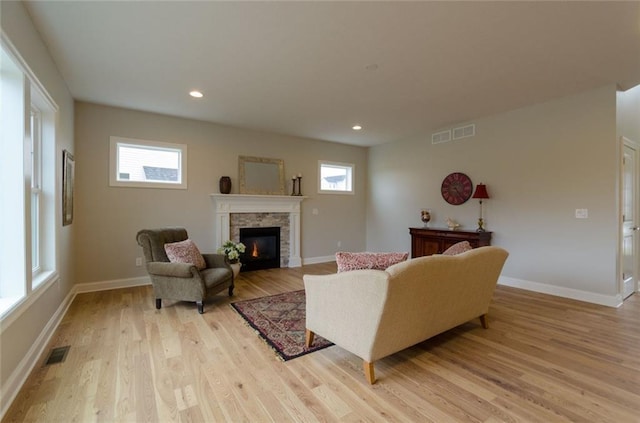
[238,156,284,195]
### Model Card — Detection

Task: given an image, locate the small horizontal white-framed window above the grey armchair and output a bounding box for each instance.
[109,137,187,189]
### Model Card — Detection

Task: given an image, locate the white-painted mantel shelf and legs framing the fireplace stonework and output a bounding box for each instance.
[211,194,307,267]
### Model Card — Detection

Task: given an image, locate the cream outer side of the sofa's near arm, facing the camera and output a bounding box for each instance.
[304,270,389,361]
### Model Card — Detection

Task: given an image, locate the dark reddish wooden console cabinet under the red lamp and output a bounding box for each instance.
[409,228,491,257]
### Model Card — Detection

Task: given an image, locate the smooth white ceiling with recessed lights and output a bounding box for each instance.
[25,1,640,146]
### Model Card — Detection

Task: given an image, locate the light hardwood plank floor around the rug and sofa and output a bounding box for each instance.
[3,264,640,423]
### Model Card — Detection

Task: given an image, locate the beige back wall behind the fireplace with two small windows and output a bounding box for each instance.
[74,102,367,283]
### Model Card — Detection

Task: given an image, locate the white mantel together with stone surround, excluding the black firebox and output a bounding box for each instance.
[211,194,306,267]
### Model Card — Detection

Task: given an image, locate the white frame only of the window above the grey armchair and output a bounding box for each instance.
[109,136,187,189]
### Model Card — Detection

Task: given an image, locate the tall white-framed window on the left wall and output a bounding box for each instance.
[0,35,58,318]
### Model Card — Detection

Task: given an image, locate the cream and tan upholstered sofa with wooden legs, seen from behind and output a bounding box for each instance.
[304,247,508,383]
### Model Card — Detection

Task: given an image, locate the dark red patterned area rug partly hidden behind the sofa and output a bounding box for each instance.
[231,289,333,361]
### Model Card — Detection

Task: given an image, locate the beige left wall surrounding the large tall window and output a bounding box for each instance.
[0,1,75,410]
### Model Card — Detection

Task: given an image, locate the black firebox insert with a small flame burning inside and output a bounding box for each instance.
[240,226,280,271]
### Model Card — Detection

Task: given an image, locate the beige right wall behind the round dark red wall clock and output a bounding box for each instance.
[367,86,619,303]
